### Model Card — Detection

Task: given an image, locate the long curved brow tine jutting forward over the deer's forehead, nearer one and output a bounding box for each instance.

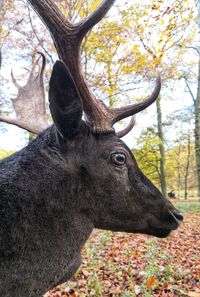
[112,70,161,125]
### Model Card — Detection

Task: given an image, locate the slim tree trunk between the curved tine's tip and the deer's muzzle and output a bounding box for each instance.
[156,96,167,197]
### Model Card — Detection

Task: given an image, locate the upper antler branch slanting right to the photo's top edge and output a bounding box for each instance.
[77,0,116,38]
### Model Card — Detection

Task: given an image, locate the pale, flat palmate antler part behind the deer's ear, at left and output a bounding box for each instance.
[0,52,48,134]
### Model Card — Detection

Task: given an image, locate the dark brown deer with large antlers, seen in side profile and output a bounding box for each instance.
[0,0,183,297]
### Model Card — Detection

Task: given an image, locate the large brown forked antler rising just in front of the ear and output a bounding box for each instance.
[27,0,161,136]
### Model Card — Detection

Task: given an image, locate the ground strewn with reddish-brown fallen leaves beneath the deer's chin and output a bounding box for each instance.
[44,214,200,297]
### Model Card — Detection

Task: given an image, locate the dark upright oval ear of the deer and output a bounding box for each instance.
[49,61,83,138]
